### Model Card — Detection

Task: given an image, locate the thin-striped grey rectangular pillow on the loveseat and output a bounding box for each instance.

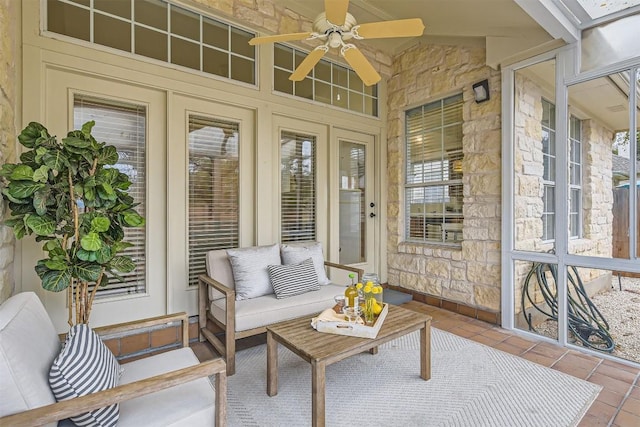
[268,258,320,299]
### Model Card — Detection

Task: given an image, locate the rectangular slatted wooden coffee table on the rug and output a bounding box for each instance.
[267,305,431,427]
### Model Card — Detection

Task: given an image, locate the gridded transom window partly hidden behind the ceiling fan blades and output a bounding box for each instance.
[273,43,378,117]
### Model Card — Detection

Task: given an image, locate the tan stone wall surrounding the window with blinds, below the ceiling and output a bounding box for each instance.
[387,45,501,311]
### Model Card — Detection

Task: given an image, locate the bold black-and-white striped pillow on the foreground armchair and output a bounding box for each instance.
[49,324,122,427]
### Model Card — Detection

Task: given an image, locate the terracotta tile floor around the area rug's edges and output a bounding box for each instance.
[192,301,640,427]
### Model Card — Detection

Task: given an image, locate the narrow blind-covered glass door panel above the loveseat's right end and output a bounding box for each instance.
[280,132,316,243]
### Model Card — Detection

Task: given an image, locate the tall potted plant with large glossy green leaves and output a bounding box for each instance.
[0,121,145,325]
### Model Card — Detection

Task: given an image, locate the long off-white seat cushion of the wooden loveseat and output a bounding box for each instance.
[210,283,345,332]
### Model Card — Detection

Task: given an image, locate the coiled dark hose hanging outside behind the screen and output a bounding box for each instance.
[522,262,615,353]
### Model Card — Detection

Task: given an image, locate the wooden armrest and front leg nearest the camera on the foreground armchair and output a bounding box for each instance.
[0,359,227,427]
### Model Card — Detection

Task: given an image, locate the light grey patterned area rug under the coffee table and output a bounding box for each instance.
[227,328,601,427]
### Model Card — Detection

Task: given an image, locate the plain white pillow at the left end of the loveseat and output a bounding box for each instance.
[227,244,282,301]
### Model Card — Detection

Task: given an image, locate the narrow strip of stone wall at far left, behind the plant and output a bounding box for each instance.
[0,0,20,302]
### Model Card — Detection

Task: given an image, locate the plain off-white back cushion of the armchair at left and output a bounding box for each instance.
[0,292,60,426]
